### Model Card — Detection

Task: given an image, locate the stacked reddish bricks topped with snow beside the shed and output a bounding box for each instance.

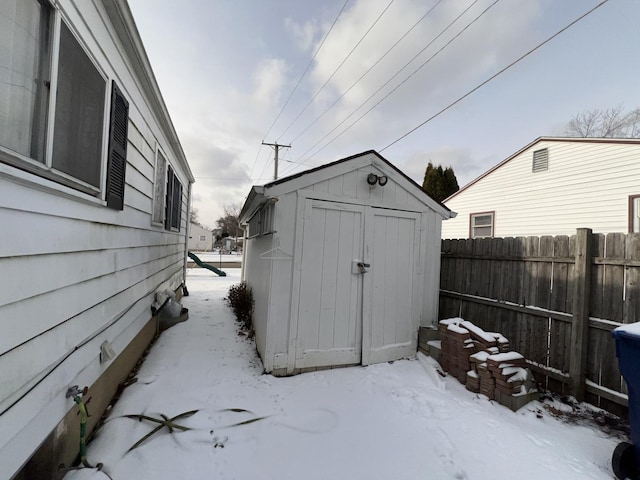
[438,318,531,406]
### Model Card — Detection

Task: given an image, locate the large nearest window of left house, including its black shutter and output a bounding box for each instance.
[0,0,129,210]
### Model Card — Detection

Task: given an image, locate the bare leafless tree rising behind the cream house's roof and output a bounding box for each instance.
[565,105,640,138]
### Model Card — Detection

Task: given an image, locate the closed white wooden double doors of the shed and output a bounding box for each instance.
[295,200,420,368]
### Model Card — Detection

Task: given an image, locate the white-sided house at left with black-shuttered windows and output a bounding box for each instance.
[0,0,194,479]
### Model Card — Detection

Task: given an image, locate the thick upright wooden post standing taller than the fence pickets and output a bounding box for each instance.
[569,228,592,401]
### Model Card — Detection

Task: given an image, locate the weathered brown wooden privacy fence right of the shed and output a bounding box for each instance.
[440,229,640,413]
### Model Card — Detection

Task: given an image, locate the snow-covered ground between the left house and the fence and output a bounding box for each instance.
[65,269,619,480]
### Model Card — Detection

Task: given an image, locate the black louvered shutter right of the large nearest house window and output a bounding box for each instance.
[106,82,129,210]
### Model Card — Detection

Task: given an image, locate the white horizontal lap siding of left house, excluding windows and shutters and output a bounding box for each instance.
[0,0,193,476]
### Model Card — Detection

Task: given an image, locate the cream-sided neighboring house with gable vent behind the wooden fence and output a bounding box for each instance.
[442,137,640,238]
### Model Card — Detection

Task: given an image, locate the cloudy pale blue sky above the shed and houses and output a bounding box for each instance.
[129,0,640,227]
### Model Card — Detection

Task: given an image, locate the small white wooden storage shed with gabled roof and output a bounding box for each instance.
[240,151,453,375]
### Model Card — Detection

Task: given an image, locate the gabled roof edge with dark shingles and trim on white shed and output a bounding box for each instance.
[240,150,455,222]
